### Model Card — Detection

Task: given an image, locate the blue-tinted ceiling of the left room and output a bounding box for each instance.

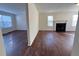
[0,3,26,14]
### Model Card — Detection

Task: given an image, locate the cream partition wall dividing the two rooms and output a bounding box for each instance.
[28,3,39,45]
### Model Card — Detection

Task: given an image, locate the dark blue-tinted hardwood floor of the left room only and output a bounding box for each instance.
[3,31,28,56]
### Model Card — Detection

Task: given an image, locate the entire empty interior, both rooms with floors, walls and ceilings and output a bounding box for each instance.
[0,3,79,56]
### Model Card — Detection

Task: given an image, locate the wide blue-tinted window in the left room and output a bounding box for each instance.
[0,15,12,28]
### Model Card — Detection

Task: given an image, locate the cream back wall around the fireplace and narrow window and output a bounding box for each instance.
[39,12,78,31]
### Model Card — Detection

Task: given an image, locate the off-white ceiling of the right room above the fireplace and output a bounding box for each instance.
[35,3,78,12]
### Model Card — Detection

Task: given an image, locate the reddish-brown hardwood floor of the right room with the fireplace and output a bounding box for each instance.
[25,31,74,56]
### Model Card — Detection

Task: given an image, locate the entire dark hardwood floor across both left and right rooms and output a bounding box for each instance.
[4,31,74,56]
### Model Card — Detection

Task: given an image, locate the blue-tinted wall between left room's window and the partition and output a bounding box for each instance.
[16,4,28,30]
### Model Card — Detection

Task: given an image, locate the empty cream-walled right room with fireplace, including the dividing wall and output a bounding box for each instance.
[26,3,78,56]
